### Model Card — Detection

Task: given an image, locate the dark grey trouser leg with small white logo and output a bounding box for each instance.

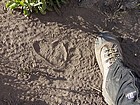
[106,59,140,105]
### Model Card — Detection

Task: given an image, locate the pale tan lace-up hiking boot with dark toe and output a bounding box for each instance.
[95,33,123,105]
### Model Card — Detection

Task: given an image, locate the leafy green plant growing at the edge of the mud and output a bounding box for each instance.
[6,0,68,16]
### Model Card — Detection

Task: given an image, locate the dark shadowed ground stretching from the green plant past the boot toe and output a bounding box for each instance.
[30,2,140,71]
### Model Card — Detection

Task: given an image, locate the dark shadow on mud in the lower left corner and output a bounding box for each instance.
[0,74,48,105]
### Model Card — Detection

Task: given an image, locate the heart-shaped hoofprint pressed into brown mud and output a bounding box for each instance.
[33,40,67,69]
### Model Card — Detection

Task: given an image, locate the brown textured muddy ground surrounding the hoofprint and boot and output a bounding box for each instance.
[0,0,140,105]
